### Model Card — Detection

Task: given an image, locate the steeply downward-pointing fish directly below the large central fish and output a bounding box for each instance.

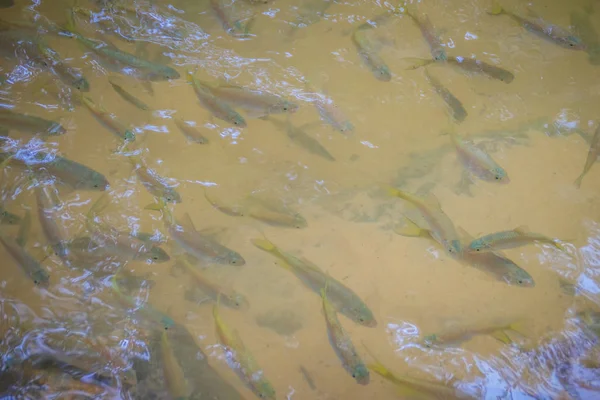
[321,282,370,385]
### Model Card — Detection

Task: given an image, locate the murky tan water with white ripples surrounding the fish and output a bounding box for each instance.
[0,0,600,399]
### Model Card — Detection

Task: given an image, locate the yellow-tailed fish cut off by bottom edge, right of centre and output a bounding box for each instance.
[365,346,462,400]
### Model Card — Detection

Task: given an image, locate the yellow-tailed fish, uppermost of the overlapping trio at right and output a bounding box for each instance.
[387,188,462,256]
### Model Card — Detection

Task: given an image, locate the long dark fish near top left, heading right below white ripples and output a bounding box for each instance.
[63,9,180,80]
